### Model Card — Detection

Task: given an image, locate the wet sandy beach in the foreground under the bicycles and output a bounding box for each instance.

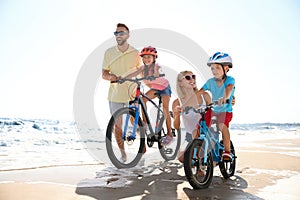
[0,138,300,200]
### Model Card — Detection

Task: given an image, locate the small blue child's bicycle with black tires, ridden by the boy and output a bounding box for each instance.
[184,102,237,189]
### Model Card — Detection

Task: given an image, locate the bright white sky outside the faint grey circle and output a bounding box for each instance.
[0,0,300,123]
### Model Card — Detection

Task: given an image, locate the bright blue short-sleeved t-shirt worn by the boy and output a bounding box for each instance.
[202,76,235,113]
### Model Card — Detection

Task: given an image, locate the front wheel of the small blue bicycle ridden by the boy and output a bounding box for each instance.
[183,139,214,189]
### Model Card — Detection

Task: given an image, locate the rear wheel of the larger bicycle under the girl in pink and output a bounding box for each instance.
[158,117,181,161]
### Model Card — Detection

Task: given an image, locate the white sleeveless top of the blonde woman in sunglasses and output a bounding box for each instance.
[178,95,206,133]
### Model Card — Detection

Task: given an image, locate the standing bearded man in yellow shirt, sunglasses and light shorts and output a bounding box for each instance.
[102,23,142,162]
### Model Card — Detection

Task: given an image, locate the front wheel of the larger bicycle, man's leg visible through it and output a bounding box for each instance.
[106,108,146,169]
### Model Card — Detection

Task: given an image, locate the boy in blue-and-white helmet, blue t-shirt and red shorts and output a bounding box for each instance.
[200,52,235,161]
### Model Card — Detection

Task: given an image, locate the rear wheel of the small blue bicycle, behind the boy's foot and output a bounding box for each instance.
[219,140,237,179]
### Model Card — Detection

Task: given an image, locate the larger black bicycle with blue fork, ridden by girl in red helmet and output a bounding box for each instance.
[106,74,181,168]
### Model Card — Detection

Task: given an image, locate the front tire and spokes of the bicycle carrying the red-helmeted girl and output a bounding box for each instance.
[105,107,146,169]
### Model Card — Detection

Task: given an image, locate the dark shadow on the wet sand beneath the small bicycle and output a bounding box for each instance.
[76,162,261,200]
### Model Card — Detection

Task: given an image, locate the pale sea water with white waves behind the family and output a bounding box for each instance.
[0,118,300,171]
